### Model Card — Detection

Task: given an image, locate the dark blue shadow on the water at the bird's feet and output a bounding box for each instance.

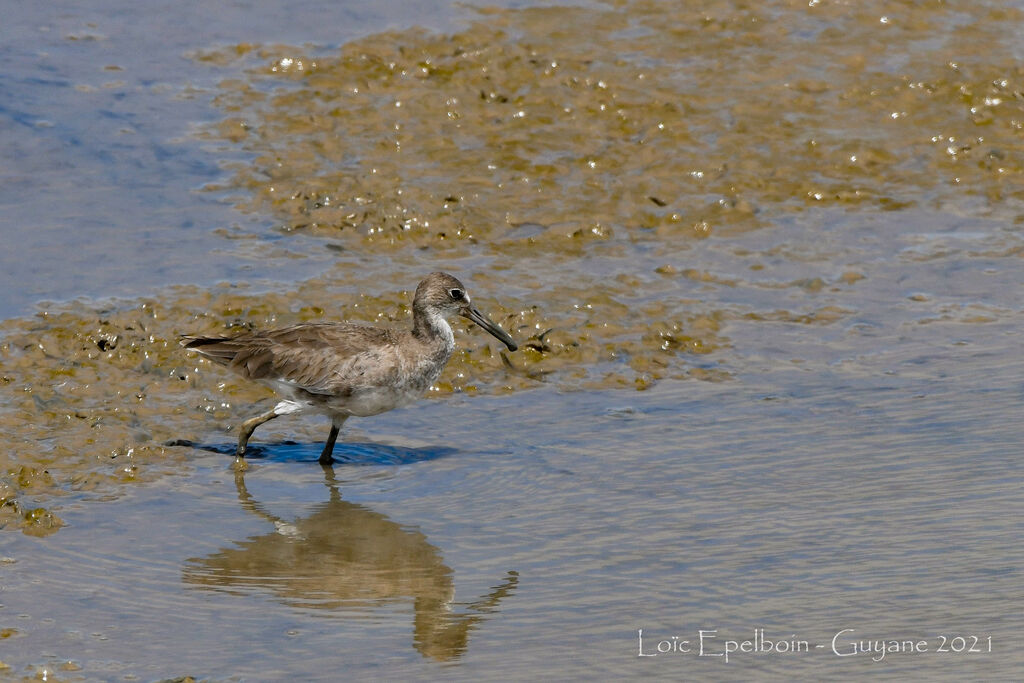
[167,439,459,466]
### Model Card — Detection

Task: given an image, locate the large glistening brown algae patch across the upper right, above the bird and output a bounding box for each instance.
[195,0,1024,246]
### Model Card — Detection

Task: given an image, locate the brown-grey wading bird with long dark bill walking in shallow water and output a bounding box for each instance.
[181,272,517,465]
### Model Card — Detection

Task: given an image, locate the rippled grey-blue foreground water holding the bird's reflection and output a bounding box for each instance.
[3,371,1024,680]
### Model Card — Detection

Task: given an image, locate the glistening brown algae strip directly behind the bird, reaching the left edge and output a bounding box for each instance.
[0,274,729,535]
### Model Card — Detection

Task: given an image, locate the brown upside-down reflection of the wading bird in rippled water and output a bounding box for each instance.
[183,465,518,660]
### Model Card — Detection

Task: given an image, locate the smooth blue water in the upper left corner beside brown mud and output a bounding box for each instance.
[0,1,505,317]
